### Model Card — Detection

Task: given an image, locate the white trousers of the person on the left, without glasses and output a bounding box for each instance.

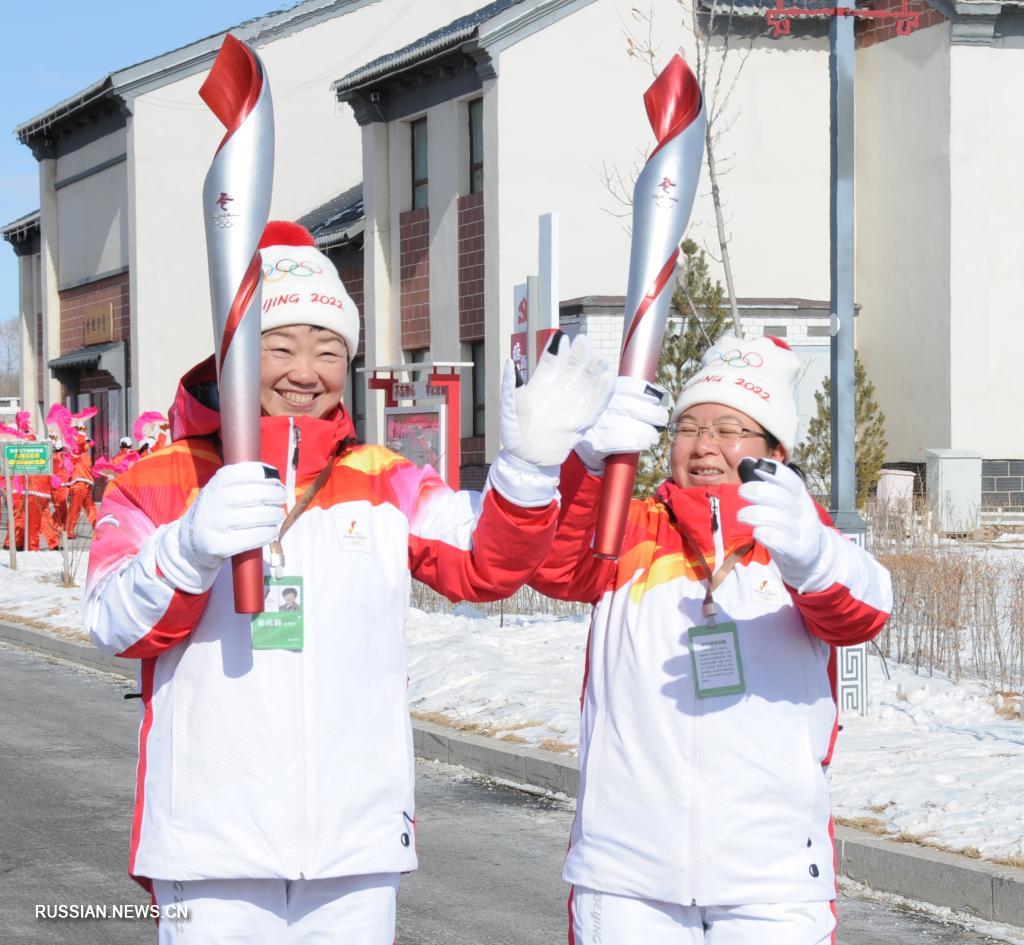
[153,873,398,945]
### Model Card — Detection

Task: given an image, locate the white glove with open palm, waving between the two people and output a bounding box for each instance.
[498,332,612,467]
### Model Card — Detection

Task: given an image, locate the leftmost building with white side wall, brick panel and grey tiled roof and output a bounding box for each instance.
[4,0,487,462]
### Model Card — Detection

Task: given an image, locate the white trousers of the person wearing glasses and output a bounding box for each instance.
[569,886,836,945]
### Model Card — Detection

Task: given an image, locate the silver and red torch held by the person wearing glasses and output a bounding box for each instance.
[594,54,706,558]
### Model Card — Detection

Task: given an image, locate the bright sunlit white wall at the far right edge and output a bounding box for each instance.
[944,37,1024,459]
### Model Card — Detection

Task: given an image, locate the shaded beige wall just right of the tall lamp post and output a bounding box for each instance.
[855,24,950,462]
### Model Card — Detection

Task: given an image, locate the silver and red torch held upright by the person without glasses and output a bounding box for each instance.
[199,35,273,613]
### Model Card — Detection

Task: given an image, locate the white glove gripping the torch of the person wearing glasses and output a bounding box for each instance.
[575,377,669,476]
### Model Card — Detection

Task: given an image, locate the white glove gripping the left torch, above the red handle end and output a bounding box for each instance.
[156,463,288,594]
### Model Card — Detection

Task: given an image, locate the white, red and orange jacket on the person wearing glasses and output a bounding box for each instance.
[530,456,892,906]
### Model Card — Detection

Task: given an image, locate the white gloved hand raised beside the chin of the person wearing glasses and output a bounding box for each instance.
[736,462,846,594]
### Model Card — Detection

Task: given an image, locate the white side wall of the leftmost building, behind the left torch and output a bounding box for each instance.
[131,0,487,411]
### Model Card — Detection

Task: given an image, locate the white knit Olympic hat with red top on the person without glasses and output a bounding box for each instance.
[259,220,359,357]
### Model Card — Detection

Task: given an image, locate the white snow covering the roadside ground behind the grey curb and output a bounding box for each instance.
[0,552,1024,861]
